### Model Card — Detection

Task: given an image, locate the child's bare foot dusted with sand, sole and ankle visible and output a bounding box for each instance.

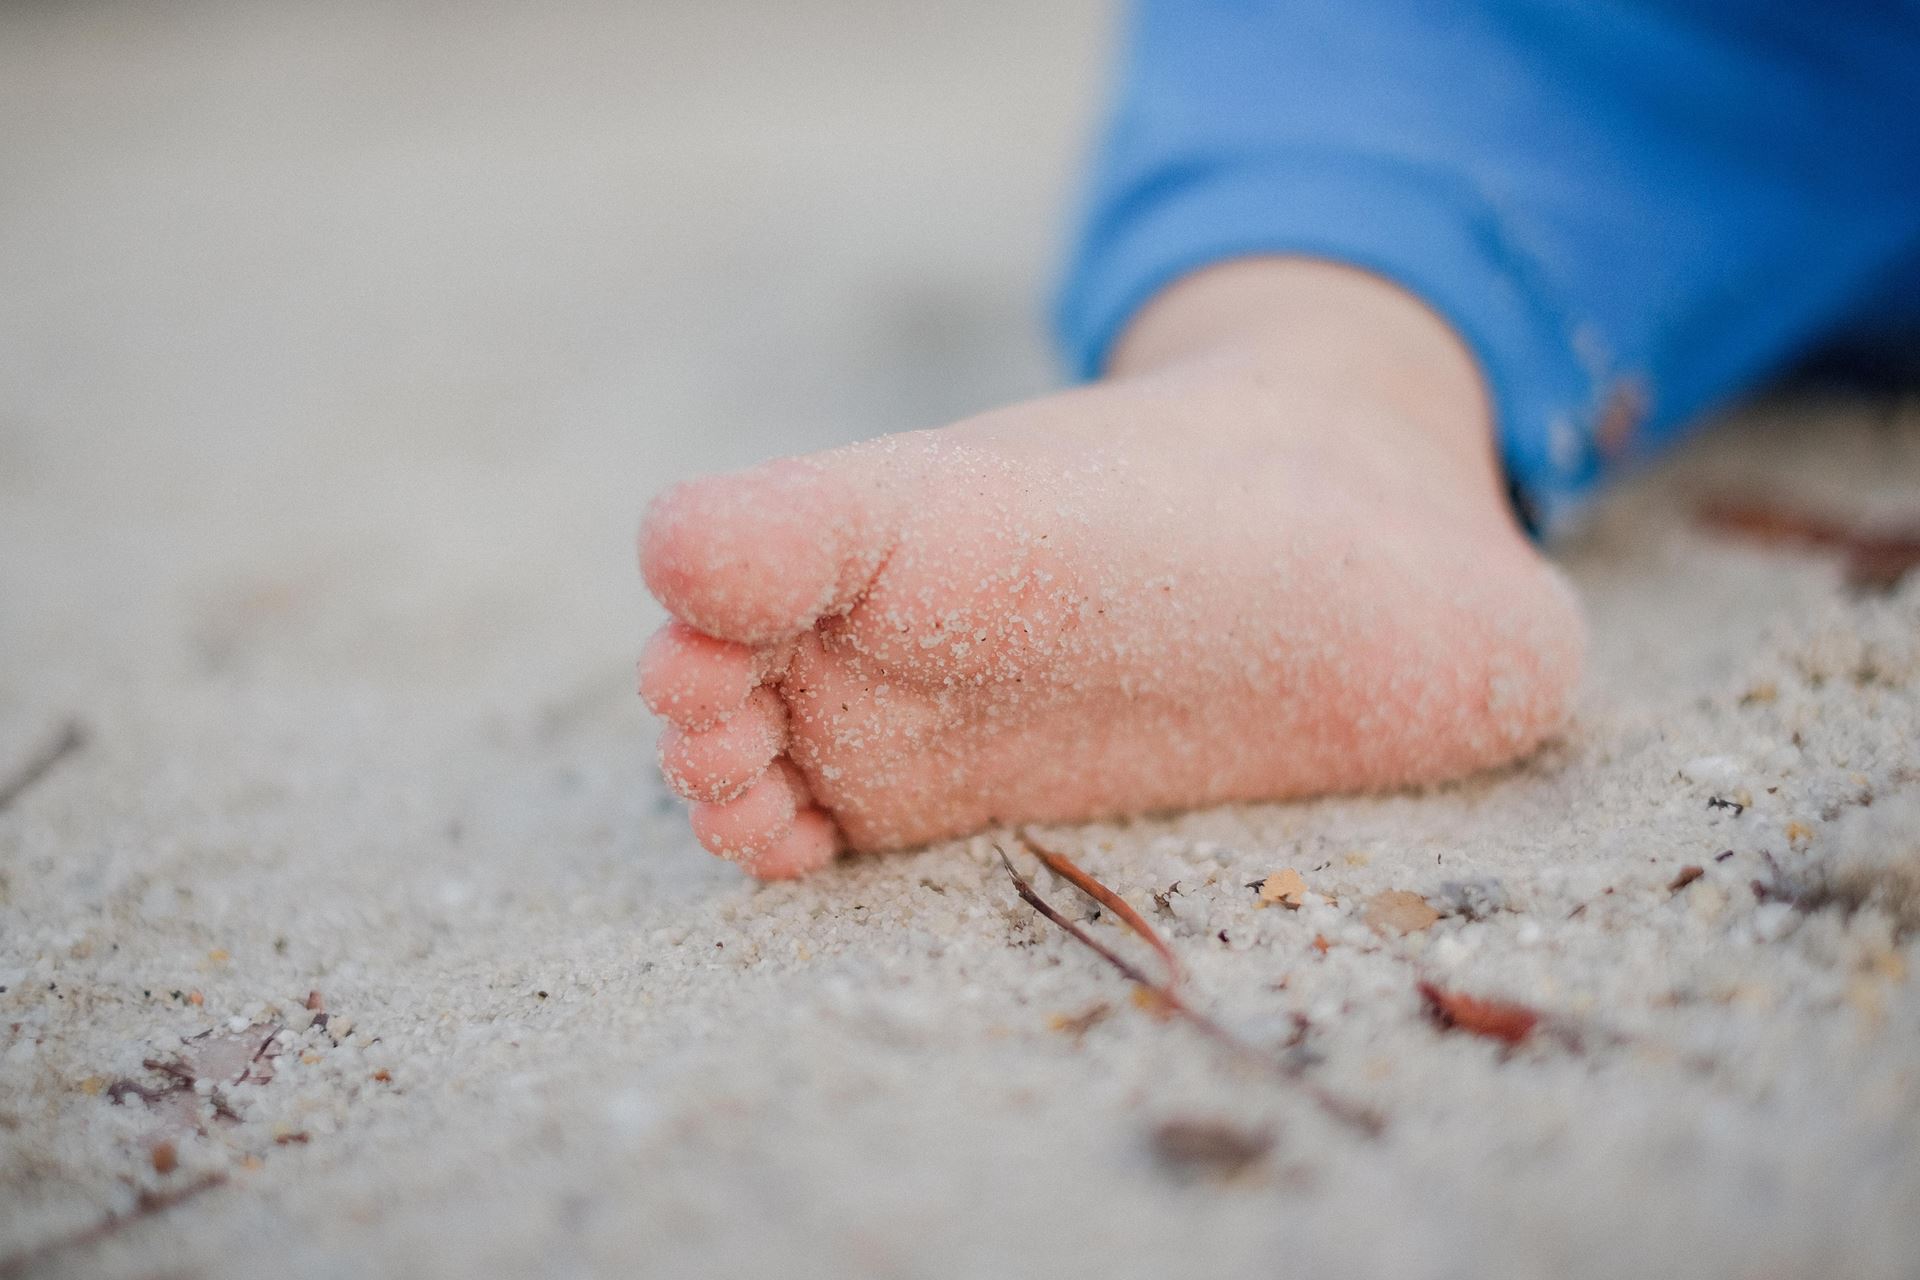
[641,259,1582,877]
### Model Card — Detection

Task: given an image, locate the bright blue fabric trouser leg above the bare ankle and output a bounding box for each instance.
[1058,0,1920,528]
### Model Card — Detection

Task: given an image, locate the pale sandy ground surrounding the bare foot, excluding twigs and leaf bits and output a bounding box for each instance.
[0,2,1920,1278]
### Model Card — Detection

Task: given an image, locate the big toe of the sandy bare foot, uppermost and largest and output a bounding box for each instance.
[639,455,885,645]
